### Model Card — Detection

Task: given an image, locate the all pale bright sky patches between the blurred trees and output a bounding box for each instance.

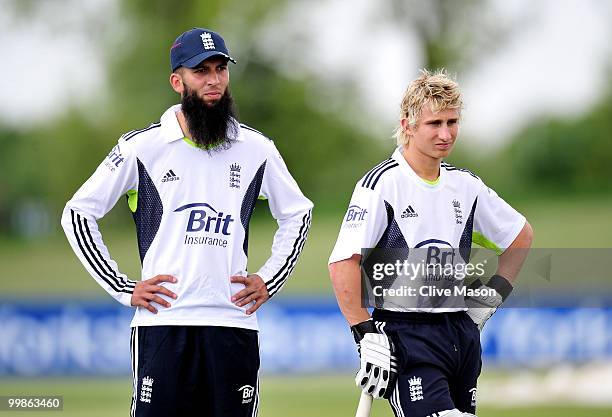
[0,0,612,148]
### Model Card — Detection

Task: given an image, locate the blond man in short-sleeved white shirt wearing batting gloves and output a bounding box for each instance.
[329,70,533,417]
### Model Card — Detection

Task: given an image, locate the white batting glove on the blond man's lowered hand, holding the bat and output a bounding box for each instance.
[351,319,397,399]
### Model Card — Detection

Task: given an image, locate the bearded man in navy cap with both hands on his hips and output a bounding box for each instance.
[62,28,313,417]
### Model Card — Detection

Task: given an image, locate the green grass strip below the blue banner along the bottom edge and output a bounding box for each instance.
[0,375,612,417]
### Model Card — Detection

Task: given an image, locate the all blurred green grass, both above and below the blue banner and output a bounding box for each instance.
[0,198,612,417]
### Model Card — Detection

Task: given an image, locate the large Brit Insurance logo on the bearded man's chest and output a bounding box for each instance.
[174,203,235,248]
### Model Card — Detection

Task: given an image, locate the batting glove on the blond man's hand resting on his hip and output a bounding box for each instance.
[465,275,512,331]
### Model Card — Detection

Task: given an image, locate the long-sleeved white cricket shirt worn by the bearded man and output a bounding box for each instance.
[62,105,313,329]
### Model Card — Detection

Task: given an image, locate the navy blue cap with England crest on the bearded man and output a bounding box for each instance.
[170,28,236,71]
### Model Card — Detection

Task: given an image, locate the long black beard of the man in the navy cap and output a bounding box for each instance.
[181,86,238,151]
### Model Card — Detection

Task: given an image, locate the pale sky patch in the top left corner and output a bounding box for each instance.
[0,0,124,128]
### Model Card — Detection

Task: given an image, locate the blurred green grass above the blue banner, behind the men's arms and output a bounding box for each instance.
[0,198,612,297]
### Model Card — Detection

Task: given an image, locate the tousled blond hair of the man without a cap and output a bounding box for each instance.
[393,68,463,145]
